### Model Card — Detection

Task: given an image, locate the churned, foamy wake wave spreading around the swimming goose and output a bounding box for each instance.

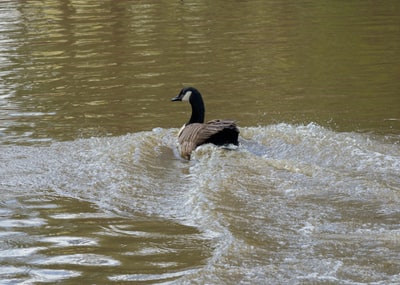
[0,124,400,283]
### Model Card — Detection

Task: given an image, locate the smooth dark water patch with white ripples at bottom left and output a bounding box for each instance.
[0,193,211,284]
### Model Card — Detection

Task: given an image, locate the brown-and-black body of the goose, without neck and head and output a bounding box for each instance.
[178,120,239,159]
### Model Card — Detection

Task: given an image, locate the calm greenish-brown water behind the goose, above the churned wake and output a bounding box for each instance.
[0,0,400,143]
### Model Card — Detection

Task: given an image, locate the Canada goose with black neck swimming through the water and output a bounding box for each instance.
[171,87,239,159]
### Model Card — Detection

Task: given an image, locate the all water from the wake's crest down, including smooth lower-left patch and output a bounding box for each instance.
[1,124,400,284]
